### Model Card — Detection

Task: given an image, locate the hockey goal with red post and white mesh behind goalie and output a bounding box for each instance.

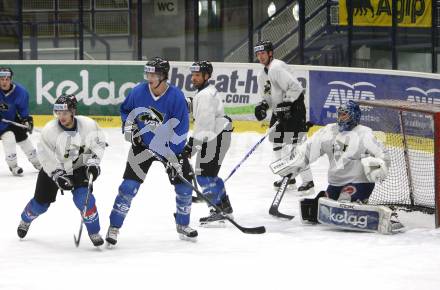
[357,100,440,227]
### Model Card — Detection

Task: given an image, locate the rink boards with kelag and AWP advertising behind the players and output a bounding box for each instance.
[0,60,440,132]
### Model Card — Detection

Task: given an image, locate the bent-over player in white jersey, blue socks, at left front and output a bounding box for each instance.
[17,95,106,246]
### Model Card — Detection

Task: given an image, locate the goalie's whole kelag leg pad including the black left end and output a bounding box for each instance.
[300,191,396,234]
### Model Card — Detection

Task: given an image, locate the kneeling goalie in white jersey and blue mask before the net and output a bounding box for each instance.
[271,100,403,233]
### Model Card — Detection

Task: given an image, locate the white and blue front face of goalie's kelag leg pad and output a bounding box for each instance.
[318,198,393,234]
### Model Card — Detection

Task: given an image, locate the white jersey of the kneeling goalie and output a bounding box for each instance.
[297,123,390,186]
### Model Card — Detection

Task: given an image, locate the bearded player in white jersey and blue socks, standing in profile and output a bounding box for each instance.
[183,61,233,227]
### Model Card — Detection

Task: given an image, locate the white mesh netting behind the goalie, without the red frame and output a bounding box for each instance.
[361,101,435,210]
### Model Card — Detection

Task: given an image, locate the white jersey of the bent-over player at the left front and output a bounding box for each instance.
[37,116,106,176]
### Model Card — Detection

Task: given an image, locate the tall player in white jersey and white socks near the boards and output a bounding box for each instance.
[254,40,314,194]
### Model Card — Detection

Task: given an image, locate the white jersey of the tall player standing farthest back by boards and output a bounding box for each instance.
[257,59,304,109]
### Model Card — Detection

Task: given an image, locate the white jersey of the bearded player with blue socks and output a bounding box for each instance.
[192,85,229,142]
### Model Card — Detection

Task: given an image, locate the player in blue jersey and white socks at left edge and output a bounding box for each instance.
[0,67,41,176]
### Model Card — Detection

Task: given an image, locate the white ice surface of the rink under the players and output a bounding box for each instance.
[0,129,440,290]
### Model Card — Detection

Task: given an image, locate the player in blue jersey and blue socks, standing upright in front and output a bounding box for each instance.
[106,57,198,245]
